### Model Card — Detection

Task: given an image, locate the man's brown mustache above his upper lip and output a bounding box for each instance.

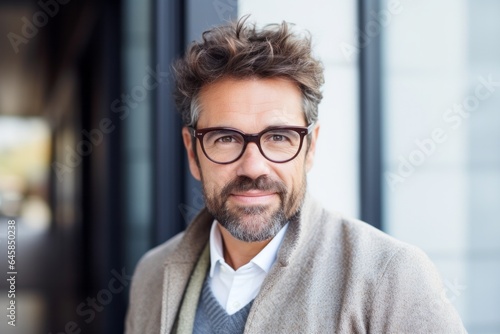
[221,175,287,199]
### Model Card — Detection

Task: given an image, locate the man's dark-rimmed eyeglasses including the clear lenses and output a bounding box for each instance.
[189,123,314,164]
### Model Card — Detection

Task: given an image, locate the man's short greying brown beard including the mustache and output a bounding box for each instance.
[202,175,306,242]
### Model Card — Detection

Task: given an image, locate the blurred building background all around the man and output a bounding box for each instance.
[0,0,500,334]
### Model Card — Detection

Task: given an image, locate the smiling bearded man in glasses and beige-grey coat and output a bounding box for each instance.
[126,20,465,334]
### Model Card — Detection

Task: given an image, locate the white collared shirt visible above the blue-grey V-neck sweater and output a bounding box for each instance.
[210,220,288,315]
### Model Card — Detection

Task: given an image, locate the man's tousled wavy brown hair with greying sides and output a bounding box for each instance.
[173,16,324,126]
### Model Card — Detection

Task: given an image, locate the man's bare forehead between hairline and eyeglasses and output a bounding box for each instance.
[198,78,305,132]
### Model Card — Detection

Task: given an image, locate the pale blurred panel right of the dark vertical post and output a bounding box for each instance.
[382,1,500,333]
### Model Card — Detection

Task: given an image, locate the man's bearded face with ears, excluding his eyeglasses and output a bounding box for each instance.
[183,78,319,242]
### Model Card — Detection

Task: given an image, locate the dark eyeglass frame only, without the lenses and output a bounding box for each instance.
[188,123,315,165]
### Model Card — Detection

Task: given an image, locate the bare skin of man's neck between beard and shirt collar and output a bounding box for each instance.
[218,224,272,270]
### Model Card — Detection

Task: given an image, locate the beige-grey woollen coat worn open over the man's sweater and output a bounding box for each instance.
[126,195,465,334]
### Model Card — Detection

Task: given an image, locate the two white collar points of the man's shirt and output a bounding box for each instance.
[210,220,288,277]
